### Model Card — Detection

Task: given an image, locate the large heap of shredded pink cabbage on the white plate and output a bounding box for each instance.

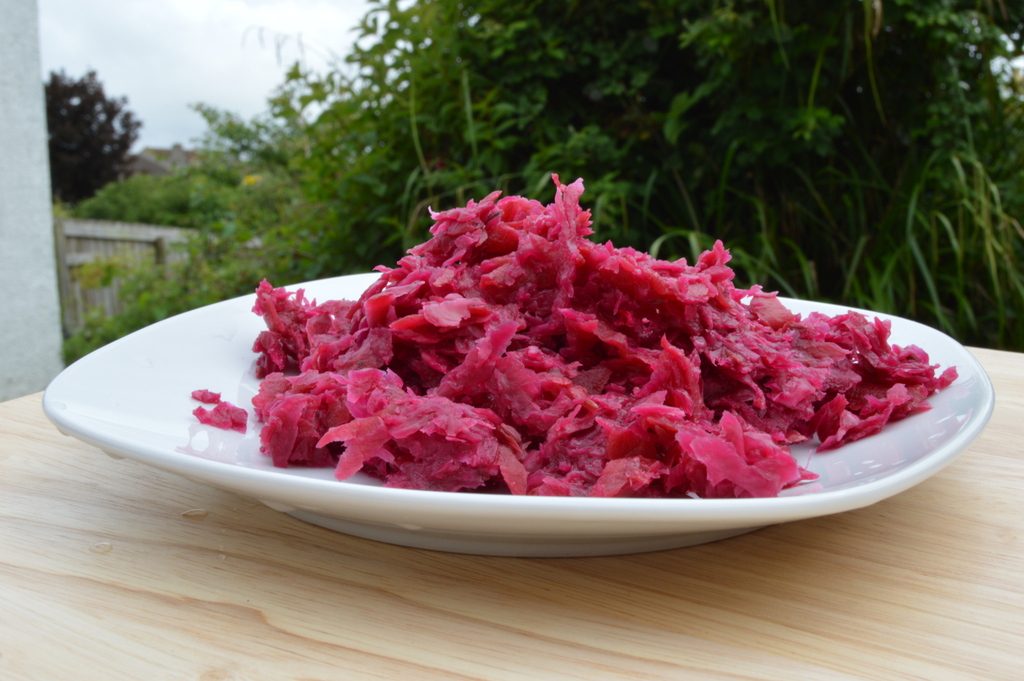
[243,175,956,498]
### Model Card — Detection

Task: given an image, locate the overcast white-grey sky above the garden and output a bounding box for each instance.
[38,0,368,148]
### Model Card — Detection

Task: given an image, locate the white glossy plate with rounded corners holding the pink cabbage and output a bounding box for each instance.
[43,274,994,556]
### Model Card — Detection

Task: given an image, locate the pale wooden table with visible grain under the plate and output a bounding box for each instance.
[0,350,1024,681]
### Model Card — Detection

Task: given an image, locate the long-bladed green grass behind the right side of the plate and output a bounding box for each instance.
[650,148,1024,347]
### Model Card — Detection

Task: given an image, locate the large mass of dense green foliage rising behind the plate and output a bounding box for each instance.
[64,0,1024,364]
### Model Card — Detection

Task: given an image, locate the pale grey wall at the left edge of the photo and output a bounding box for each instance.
[0,0,60,399]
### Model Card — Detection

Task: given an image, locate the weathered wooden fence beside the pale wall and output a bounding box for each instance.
[54,218,190,334]
